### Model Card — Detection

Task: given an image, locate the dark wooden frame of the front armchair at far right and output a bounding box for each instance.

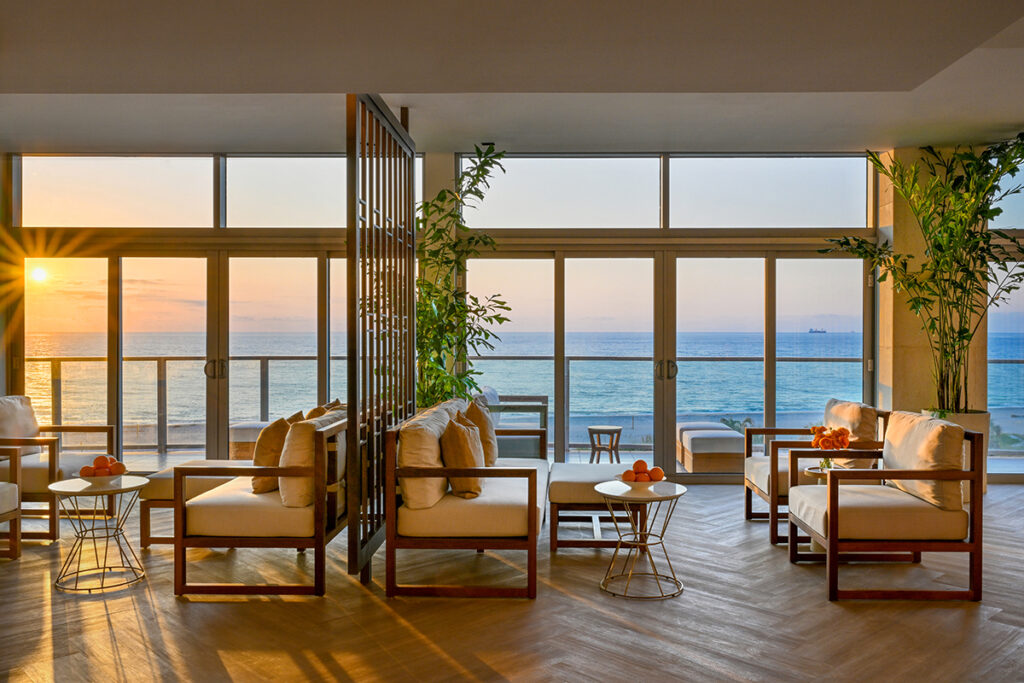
[788,432,984,601]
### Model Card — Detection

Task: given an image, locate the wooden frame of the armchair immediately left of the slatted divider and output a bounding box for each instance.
[174,420,349,595]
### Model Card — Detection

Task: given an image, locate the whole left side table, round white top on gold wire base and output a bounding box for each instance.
[49,474,150,593]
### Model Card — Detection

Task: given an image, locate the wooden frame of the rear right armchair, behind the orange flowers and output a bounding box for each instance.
[743,410,890,546]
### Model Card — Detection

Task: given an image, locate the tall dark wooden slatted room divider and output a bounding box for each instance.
[346,94,416,583]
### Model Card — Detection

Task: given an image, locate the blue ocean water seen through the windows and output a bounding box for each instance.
[27,332,1024,447]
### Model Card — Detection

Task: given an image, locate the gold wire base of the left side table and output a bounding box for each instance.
[53,490,145,593]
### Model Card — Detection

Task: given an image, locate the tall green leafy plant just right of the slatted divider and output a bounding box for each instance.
[416,144,509,408]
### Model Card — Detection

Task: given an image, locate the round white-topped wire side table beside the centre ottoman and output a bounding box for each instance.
[594,481,686,600]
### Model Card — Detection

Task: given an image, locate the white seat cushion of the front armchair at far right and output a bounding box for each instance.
[790,484,968,541]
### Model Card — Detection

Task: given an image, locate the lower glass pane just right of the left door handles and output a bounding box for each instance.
[228,258,317,457]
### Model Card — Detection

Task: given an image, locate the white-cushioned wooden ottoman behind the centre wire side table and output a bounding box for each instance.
[548,463,629,552]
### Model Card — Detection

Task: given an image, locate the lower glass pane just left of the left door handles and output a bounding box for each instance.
[121,258,207,471]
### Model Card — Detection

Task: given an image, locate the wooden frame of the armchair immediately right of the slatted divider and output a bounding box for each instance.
[384,425,546,598]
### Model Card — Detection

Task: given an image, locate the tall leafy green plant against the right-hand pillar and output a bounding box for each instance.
[824,133,1024,475]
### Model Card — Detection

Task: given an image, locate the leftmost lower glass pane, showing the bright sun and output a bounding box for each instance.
[25,258,108,452]
